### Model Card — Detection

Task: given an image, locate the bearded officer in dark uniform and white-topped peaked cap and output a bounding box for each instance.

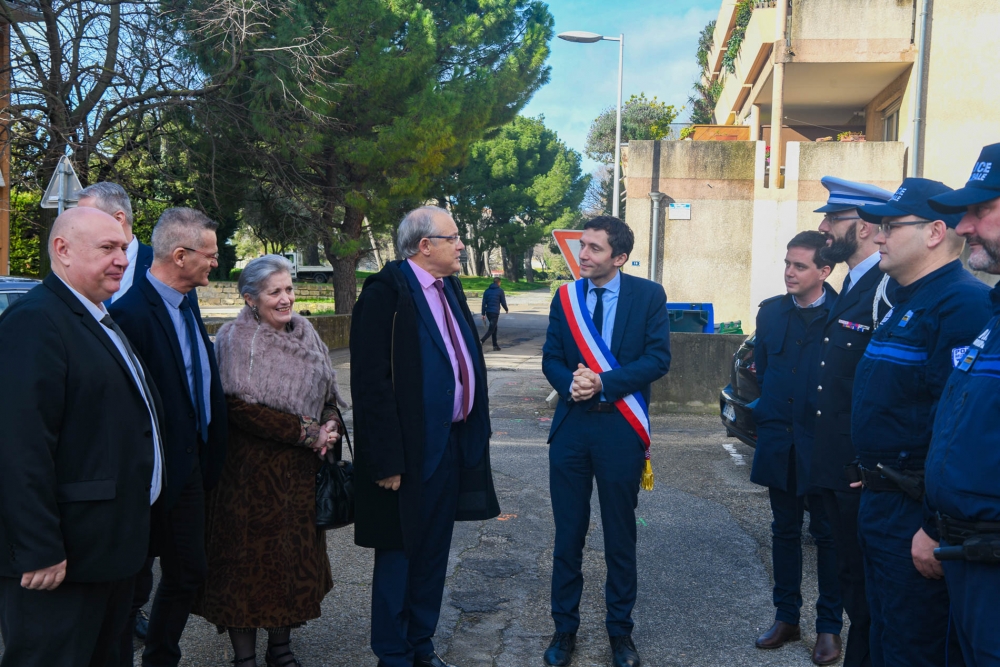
[810,176,894,667]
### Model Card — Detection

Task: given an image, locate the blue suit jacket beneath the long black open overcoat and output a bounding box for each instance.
[400,262,490,480]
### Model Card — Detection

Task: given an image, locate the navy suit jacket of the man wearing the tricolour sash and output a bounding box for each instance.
[542,273,670,442]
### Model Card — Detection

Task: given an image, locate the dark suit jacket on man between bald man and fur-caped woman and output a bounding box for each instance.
[108,276,228,508]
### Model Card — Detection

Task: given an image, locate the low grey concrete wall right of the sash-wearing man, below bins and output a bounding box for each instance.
[649,333,746,413]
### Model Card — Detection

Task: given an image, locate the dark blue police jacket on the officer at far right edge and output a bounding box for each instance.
[926,287,1000,521]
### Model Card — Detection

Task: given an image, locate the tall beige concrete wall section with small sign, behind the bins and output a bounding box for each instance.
[625,141,755,328]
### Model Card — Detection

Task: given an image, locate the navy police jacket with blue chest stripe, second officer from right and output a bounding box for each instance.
[851,260,991,537]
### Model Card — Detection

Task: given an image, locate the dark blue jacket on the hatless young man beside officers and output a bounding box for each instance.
[750,285,837,496]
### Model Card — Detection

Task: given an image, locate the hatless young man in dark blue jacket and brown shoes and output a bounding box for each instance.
[750,231,844,665]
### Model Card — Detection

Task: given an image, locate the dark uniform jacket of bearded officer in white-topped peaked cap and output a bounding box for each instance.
[810,266,895,493]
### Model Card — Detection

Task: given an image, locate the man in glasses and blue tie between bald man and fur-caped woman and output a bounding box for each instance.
[111,208,227,667]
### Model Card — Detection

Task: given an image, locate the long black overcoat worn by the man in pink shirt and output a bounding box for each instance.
[351,262,500,554]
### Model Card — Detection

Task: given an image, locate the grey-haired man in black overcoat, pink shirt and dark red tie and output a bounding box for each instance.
[351,206,500,667]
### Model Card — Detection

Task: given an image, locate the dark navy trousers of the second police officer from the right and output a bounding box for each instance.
[858,490,963,667]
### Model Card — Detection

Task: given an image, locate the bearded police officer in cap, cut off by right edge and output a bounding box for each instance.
[926,144,1000,667]
